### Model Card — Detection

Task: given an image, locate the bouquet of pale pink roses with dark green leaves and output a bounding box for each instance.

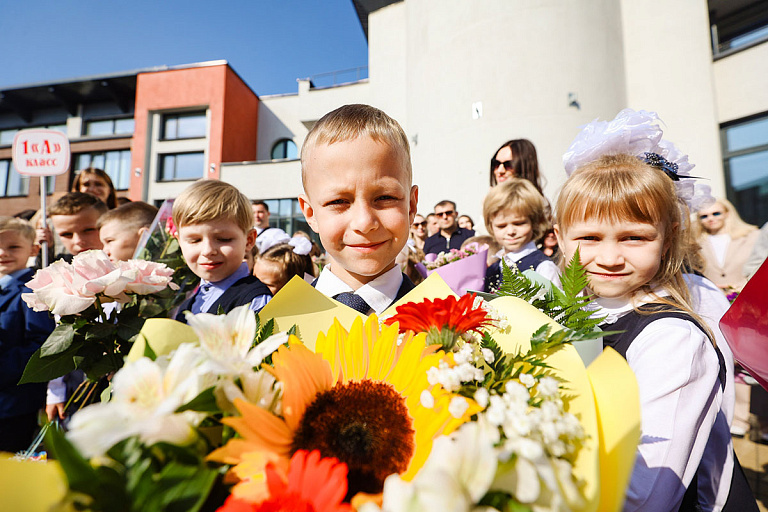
[21,251,176,392]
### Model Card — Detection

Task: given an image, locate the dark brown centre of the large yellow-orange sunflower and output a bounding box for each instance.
[292,380,414,499]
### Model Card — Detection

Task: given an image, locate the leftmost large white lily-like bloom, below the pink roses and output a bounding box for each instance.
[67,344,207,457]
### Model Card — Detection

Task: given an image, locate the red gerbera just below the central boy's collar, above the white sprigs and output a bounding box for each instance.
[385,294,492,350]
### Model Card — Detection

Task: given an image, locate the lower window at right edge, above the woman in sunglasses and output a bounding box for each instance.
[722,115,768,225]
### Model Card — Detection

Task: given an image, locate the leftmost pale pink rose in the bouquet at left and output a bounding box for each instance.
[21,260,96,316]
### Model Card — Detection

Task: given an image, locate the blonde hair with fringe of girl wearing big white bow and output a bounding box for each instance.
[556,155,699,312]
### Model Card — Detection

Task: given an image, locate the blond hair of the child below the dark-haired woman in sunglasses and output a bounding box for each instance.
[483,178,549,240]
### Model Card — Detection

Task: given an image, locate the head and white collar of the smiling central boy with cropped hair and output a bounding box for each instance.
[299,105,419,314]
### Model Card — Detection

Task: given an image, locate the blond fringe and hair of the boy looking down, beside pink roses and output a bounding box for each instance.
[173,180,253,234]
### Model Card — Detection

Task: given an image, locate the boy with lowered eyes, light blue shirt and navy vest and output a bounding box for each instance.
[172,180,272,322]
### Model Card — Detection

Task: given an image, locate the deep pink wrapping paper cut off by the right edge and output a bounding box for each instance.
[720,262,768,390]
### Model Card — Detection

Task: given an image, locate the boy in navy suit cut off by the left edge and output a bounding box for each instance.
[0,217,55,452]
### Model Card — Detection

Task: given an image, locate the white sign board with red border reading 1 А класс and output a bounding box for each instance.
[13,128,70,176]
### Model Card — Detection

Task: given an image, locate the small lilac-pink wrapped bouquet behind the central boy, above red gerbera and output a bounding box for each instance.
[425,243,488,295]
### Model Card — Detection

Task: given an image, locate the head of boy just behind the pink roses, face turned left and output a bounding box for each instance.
[96,201,157,263]
